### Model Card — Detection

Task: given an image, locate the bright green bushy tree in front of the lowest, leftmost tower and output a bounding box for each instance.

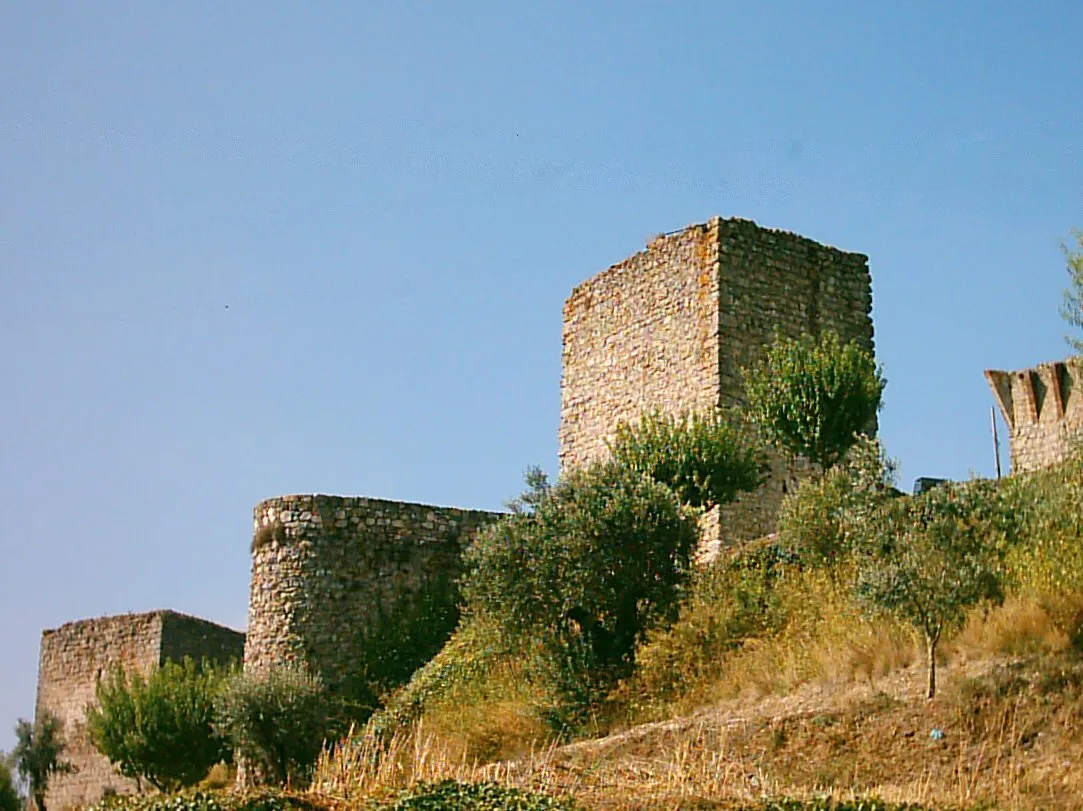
[87,657,232,793]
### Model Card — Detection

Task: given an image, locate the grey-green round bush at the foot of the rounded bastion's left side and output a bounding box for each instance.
[214,665,342,785]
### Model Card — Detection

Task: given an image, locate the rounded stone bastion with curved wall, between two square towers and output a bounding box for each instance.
[245,495,498,689]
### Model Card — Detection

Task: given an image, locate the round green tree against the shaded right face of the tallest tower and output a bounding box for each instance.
[745,331,886,473]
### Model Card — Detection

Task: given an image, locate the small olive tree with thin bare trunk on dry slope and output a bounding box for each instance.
[856,481,1007,698]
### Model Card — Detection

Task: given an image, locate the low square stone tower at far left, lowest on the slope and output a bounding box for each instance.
[35,611,245,809]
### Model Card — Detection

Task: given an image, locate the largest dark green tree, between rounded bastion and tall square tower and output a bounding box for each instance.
[464,462,697,724]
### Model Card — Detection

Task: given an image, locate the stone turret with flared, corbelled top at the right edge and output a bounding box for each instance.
[986,357,1083,473]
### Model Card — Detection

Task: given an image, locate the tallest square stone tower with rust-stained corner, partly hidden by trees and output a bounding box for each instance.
[560,218,873,553]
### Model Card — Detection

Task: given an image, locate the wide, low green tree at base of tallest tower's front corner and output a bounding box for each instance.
[609,409,765,510]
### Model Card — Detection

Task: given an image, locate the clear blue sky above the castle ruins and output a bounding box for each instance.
[0,0,1083,748]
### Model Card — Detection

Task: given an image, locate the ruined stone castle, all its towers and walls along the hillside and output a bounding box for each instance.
[36,218,1083,808]
